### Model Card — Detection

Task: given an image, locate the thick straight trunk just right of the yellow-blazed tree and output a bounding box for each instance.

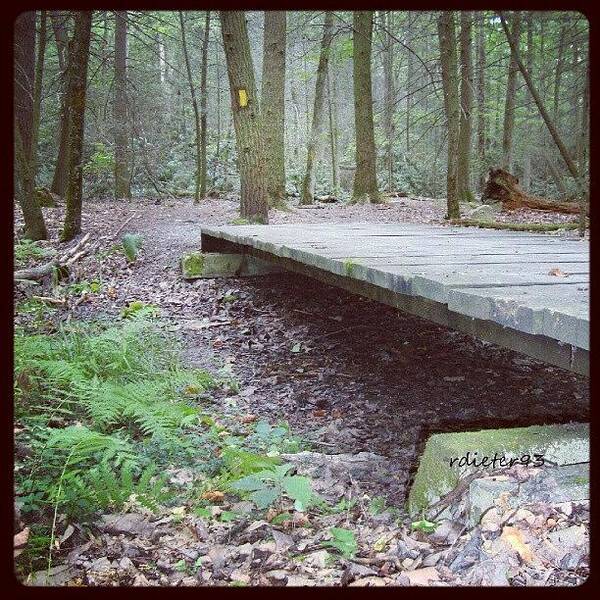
[261,10,286,206]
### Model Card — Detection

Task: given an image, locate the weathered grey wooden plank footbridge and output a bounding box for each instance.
[202,223,589,375]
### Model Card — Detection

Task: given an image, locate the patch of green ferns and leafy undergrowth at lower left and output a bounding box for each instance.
[14,310,319,572]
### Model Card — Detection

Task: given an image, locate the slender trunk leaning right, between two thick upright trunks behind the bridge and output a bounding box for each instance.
[300,11,333,204]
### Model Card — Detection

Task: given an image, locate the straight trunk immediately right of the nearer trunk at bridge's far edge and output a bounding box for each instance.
[456,11,473,202]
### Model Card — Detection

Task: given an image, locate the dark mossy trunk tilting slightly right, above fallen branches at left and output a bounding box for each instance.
[61,10,92,241]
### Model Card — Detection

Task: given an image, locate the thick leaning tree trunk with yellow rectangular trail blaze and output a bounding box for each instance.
[220,10,269,223]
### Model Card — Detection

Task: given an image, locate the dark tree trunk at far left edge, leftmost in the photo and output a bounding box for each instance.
[14,11,48,240]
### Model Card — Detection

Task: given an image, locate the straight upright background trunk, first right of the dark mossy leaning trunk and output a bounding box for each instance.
[114,11,131,200]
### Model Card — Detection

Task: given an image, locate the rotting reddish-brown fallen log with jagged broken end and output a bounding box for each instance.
[481,169,589,215]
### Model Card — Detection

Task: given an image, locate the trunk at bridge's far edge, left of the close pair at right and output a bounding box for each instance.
[437,11,460,219]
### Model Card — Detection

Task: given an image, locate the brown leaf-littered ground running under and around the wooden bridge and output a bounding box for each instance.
[17,198,589,585]
